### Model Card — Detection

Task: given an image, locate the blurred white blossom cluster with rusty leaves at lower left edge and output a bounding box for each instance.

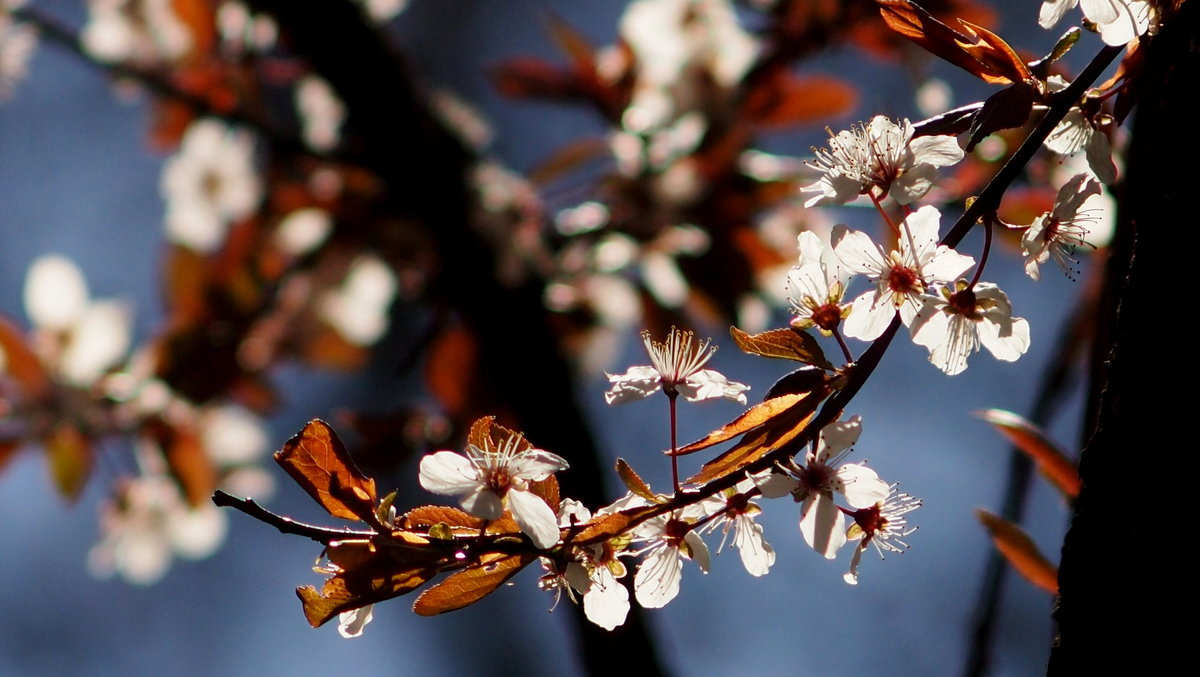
[0,254,272,583]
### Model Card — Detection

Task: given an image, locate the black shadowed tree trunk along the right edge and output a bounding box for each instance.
[1049,2,1200,676]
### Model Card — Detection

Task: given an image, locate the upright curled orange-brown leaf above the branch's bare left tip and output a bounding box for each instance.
[275,419,376,523]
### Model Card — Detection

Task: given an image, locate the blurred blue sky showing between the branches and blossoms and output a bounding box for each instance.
[0,0,1094,676]
